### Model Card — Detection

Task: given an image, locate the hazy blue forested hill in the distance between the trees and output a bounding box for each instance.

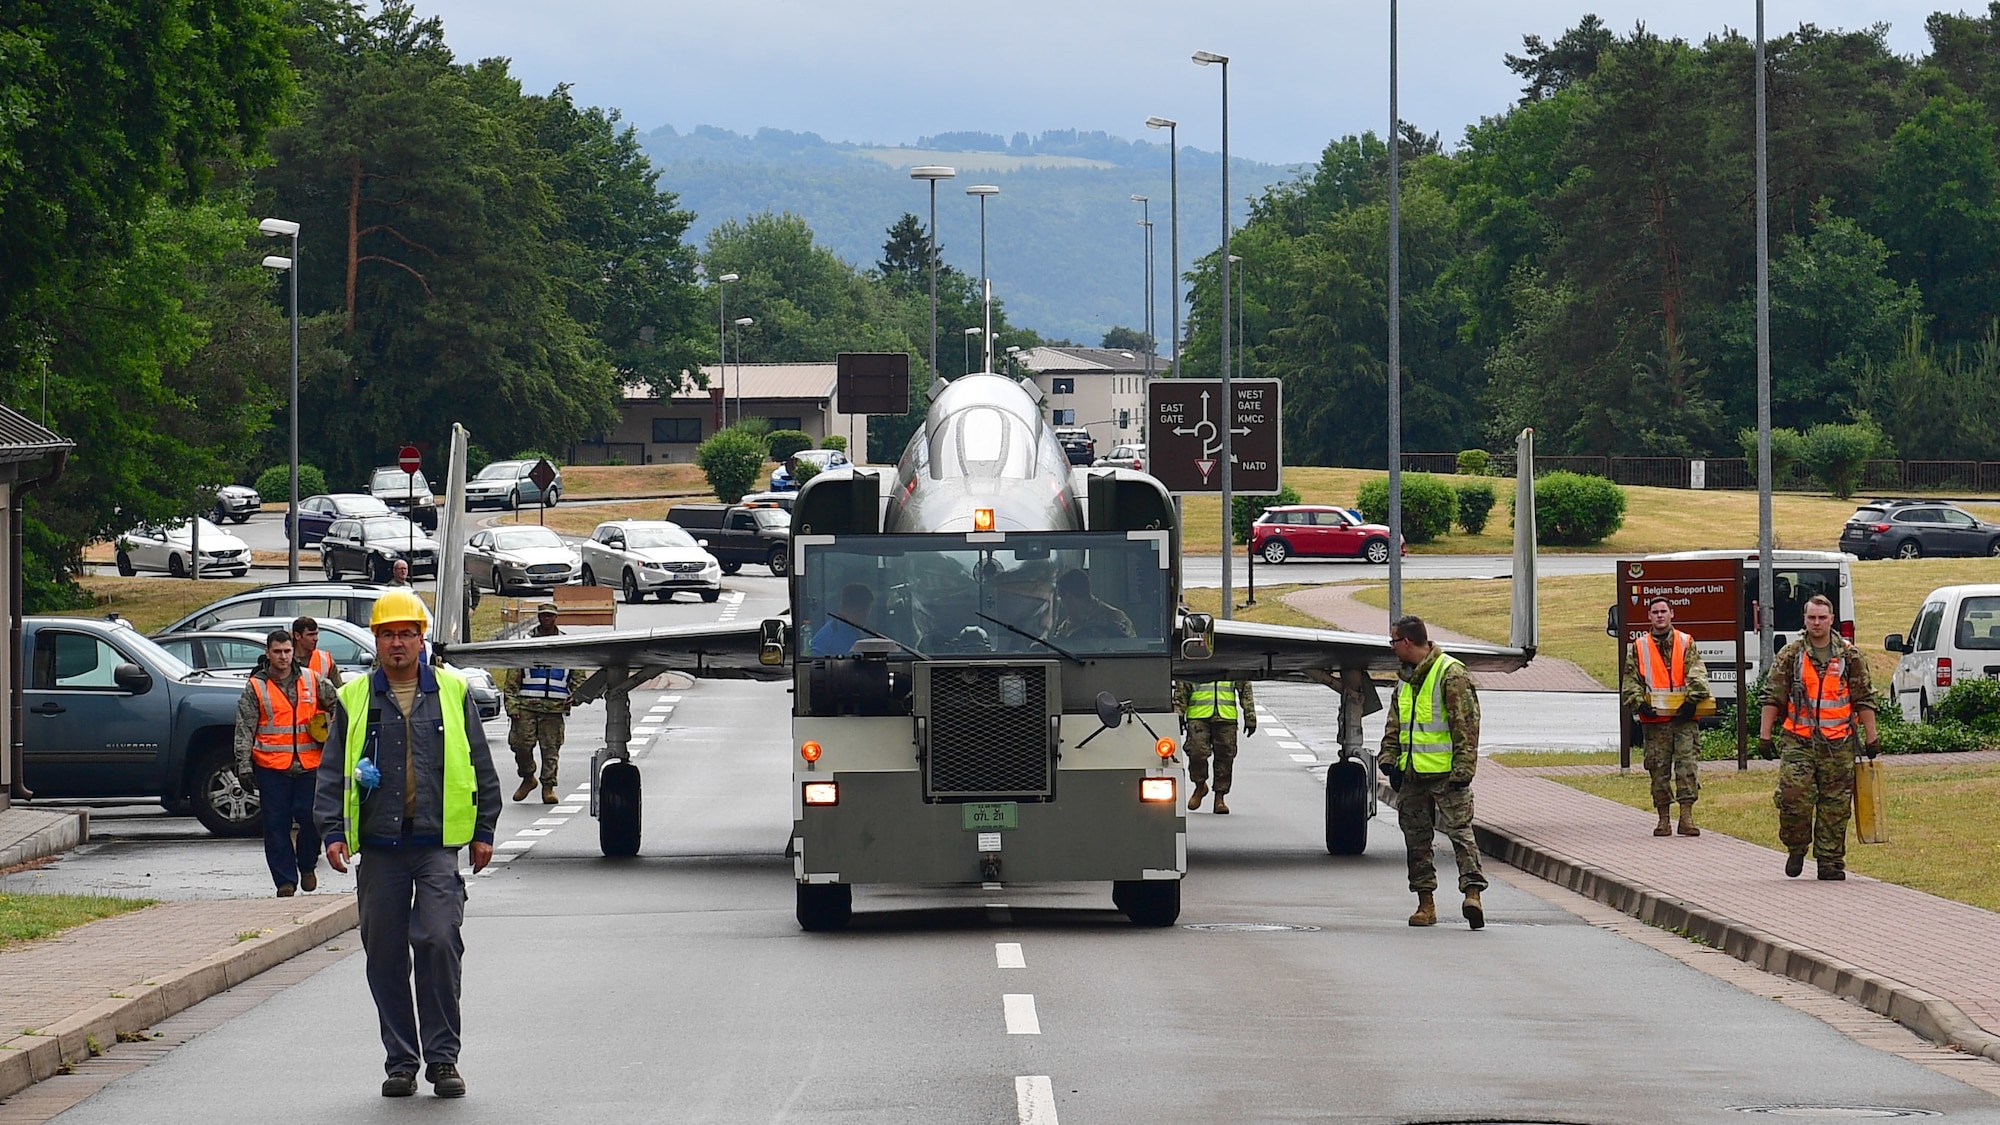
[640,126,1292,344]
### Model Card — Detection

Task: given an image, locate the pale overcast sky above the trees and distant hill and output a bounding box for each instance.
[418,0,1952,162]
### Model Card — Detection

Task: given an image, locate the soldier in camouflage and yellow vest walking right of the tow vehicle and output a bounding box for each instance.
[1380,617,1486,929]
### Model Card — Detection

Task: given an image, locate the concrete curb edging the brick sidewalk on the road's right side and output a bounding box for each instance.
[1472,808,2000,1063]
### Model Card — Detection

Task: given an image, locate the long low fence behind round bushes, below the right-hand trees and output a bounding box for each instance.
[1402,452,2000,494]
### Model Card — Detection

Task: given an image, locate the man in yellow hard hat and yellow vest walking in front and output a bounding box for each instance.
[312,591,500,1097]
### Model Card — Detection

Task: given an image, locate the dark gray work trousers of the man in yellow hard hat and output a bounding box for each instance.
[354,845,466,1073]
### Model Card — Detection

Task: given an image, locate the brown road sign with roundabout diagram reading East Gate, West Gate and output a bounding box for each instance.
[1146,378,1284,496]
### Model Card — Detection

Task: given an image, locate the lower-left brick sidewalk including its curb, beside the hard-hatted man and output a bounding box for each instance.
[0,895,356,1097]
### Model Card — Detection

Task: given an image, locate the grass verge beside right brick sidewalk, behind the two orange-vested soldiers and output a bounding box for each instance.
[1552,755,2000,911]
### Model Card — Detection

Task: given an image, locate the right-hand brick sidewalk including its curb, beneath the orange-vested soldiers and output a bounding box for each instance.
[1476,755,2000,1061]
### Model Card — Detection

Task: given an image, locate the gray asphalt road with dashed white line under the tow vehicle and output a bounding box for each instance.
[19,644,2000,1125]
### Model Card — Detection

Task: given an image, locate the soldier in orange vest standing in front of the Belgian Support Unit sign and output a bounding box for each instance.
[1618,599,1714,837]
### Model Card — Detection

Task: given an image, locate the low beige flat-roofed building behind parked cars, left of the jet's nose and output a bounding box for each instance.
[570,362,868,464]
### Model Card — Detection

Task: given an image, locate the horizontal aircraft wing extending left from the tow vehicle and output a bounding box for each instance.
[442,621,792,681]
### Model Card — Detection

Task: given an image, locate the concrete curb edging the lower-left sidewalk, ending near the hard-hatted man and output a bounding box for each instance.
[0,895,360,1097]
